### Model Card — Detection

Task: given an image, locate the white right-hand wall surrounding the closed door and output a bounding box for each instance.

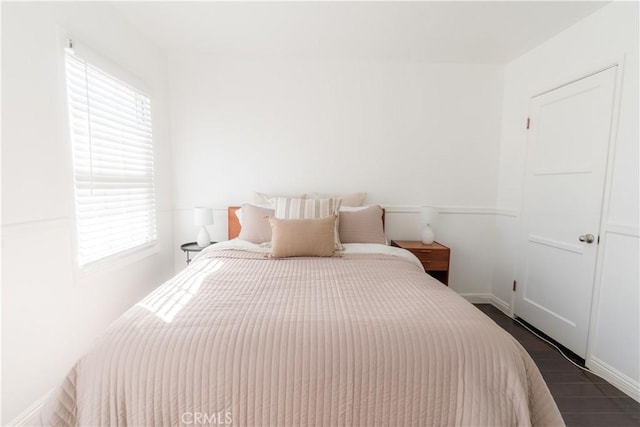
[493,2,640,398]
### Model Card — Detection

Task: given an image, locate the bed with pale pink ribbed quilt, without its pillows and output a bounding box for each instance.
[39,206,563,426]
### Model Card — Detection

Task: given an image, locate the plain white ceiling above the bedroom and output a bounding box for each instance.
[113,1,607,64]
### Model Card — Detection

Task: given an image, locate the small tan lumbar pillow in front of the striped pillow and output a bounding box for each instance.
[269,215,337,258]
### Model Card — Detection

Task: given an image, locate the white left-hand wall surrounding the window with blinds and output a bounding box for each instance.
[1,2,173,425]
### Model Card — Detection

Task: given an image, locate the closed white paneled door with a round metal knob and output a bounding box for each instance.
[515,67,616,358]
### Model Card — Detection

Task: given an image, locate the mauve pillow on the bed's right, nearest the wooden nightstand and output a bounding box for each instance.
[338,205,387,245]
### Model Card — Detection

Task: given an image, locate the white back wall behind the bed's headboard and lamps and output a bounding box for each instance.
[169,53,503,293]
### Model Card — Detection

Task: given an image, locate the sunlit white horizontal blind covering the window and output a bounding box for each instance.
[65,42,156,265]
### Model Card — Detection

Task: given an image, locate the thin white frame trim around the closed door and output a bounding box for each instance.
[511,53,626,367]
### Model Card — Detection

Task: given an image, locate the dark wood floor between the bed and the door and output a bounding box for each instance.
[476,304,640,427]
